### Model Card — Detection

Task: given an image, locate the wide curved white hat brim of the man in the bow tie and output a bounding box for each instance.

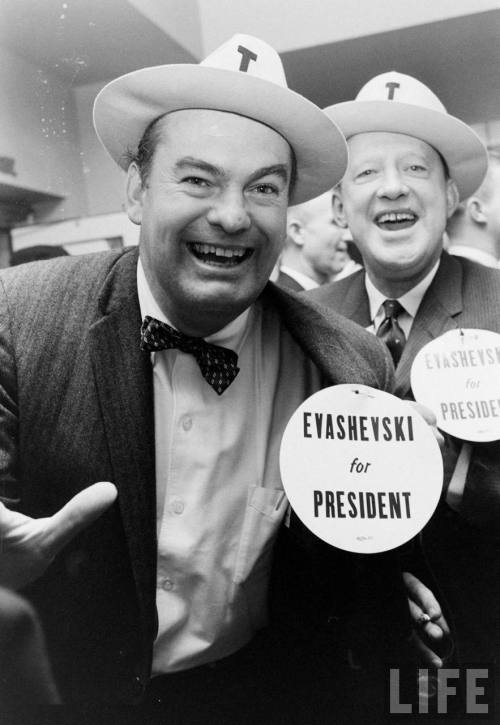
[94,64,347,204]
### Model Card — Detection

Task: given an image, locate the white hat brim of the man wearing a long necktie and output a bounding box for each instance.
[324,101,488,199]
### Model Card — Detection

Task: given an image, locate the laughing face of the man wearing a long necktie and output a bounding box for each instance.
[334,133,456,288]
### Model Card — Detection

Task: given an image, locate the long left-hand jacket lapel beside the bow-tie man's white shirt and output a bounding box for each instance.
[90,250,156,641]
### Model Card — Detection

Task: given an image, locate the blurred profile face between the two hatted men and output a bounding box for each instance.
[302,192,346,277]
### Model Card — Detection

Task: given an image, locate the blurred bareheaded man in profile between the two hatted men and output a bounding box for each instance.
[276,191,347,292]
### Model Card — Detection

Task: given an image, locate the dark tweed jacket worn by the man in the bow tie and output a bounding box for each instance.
[0,250,407,702]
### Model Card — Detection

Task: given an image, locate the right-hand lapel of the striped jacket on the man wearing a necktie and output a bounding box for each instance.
[395,252,463,397]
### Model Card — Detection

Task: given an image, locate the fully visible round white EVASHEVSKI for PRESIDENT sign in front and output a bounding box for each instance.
[280,385,443,553]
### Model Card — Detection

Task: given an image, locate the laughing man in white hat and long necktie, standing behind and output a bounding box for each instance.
[310,72,500,688]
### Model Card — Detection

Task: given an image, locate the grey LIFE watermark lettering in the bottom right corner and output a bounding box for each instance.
[386,664,495,723]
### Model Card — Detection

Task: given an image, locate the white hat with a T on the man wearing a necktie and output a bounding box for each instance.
[324,71,488,199]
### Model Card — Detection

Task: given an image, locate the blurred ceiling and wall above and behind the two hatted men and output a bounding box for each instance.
[0,0,500,267]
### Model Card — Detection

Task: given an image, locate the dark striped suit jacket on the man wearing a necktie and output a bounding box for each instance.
[308,252,500,668]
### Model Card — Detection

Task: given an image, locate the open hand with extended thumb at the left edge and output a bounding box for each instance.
[0,481,117,589]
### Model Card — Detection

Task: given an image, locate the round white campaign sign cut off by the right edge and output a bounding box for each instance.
[411,330,500,442]
